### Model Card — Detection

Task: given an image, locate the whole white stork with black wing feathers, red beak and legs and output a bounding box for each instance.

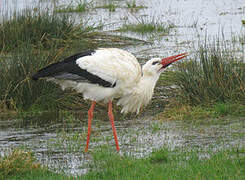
[32,48,188,152]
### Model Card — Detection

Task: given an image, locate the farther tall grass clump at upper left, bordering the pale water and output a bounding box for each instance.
[0,10,83,53]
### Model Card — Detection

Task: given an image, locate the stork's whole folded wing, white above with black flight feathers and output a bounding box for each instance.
[32,48,141,87]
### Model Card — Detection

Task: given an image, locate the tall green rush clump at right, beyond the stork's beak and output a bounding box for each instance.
[172,42,245,105]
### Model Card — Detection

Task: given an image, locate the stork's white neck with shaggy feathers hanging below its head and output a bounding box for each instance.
[118,75,158,113]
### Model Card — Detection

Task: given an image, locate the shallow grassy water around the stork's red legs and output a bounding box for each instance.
[0,112,245,175]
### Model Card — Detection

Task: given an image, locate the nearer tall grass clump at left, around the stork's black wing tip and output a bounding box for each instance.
[0,45,86,111]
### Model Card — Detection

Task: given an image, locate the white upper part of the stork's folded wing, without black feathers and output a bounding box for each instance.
[76,48,141,86]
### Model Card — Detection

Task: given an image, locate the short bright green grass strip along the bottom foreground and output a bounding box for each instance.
[2,148,245,180]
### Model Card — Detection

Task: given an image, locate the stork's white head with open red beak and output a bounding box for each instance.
[142,53,188,76]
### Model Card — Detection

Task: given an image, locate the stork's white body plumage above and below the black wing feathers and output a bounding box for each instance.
[74,48,141,111]
